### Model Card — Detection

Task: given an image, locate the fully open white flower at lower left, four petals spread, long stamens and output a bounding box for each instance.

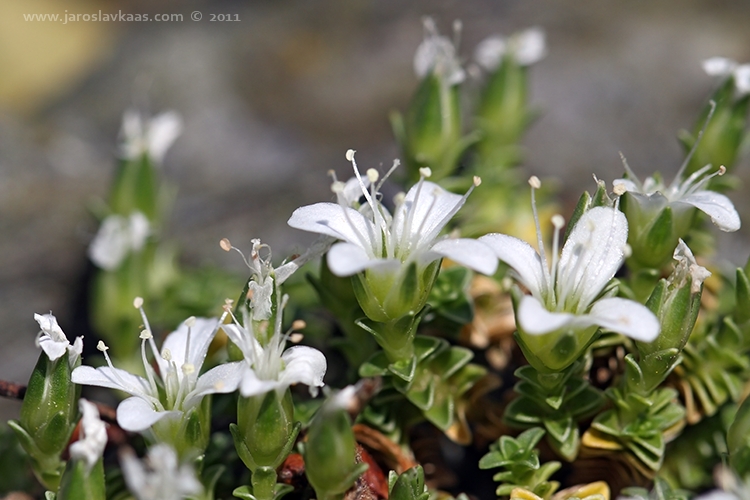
[72,306,241,432]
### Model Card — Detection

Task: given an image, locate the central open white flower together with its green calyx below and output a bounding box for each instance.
[288,150,497,321]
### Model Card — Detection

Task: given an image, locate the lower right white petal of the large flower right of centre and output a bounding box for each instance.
[589,297,661,342]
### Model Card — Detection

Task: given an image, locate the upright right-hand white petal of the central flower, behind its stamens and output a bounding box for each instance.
[391,181,466,249]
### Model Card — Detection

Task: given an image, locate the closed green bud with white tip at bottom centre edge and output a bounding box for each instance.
[305,386,367,500]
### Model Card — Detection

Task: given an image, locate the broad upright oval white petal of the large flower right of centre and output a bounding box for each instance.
[556,207,628,312]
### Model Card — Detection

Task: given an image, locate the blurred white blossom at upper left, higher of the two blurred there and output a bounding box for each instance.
[120,110,182,164]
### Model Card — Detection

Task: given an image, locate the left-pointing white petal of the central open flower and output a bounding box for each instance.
[287,203,375,251]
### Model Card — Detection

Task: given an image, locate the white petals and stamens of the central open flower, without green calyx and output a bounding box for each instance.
[288,150,497,276]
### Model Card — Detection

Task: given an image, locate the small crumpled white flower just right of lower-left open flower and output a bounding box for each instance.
[223,297,327,397]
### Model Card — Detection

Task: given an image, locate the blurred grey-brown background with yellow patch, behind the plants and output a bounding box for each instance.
[0,0,750,418]
